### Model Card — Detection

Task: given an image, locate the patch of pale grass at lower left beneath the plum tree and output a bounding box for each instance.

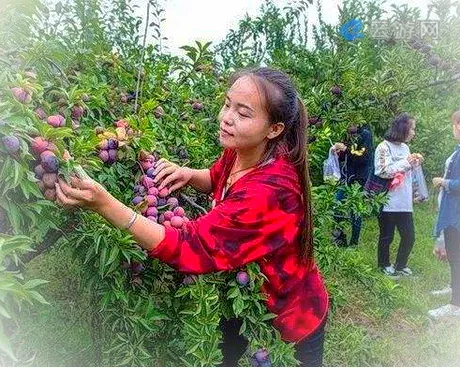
[9,247,94,366]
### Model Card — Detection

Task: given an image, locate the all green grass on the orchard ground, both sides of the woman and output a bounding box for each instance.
[8,203,460,366]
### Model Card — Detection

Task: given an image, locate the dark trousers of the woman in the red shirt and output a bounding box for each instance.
[220,318,324,367]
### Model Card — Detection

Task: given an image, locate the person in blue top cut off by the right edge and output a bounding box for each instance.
[428,111,460,318]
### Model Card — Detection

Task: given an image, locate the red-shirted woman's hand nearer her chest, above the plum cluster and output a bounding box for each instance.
[153,158,193,193]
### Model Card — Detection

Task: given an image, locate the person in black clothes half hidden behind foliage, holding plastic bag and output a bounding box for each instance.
[331,125,374,246]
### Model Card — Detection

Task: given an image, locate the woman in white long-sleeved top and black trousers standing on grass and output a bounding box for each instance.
[374,113,423,278]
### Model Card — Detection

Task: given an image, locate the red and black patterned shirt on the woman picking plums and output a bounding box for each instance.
[150,149,328,342]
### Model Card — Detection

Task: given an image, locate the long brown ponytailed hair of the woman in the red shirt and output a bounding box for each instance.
[230,67,313,260]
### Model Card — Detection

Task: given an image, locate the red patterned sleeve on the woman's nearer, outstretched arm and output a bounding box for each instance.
[150,180,302,274]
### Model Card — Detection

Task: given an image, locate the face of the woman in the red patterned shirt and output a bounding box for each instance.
[219,76,279,150]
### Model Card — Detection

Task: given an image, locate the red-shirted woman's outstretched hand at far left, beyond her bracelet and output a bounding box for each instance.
[56,177,108,212]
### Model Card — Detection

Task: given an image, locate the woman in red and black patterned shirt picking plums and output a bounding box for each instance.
[57,68,328,366]
